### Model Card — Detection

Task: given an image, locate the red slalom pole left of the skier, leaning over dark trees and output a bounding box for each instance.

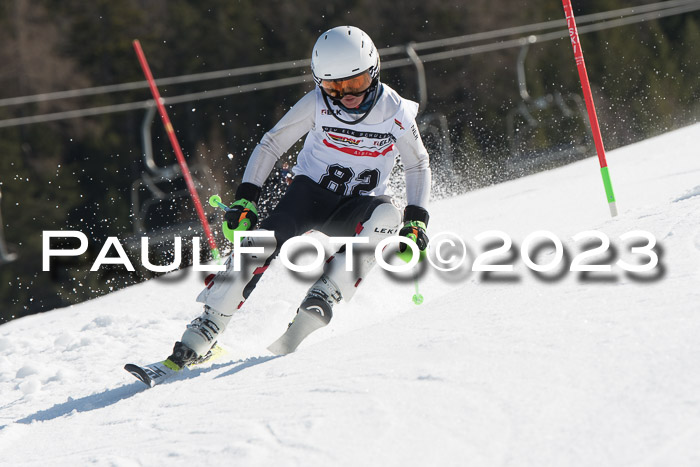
[134,39,220,260]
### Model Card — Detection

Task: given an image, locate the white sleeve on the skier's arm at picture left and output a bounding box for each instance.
[243,92,316,186]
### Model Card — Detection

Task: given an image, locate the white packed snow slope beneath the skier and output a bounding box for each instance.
[0,124,700,467]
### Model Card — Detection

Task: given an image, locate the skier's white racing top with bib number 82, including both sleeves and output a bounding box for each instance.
[243,84,431,208]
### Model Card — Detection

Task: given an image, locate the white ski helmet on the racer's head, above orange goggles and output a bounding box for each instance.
[311,26,379,86]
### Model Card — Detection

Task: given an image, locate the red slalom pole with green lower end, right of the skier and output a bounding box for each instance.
[562,0,617,217]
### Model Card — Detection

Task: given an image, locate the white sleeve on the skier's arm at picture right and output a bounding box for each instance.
[396,126,431,209]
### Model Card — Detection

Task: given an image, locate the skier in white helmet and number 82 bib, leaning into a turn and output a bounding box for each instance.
[165,26,431,369]
